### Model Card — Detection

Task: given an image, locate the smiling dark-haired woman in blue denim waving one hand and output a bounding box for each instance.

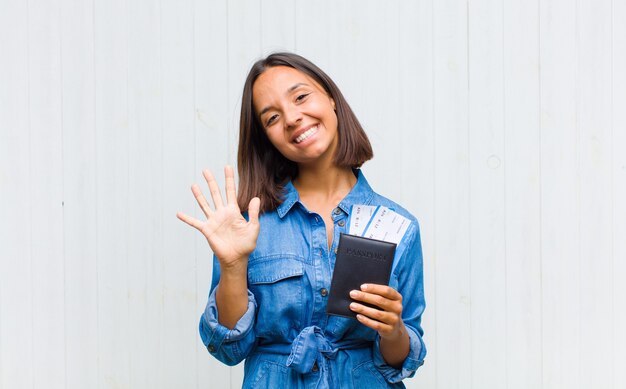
[178,53,426,388]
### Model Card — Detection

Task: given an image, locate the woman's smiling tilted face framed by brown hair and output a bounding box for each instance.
[252,66,339,165]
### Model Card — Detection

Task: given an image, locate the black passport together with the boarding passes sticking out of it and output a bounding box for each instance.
[326,205,410,318]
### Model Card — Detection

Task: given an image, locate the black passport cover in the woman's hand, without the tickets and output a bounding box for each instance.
[326,234,396,318]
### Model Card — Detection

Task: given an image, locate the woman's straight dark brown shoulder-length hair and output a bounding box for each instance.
[237,53,374,212]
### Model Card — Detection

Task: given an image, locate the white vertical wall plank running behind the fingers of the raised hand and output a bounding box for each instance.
[193,0,232,388]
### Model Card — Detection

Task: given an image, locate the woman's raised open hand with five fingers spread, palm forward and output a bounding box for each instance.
[176,166,260,268]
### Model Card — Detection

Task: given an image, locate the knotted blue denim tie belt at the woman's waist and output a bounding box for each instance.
[257,326,372,374]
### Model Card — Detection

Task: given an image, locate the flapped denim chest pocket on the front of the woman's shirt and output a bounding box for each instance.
[248,255,304,339]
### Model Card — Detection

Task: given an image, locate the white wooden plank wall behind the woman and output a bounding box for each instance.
[0,0,626,389]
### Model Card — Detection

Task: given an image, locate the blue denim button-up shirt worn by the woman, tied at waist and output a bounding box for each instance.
[200,170,426,389]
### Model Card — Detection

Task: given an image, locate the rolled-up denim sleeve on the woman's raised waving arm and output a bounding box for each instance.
[200,258,256,366]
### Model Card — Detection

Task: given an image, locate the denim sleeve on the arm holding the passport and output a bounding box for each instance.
[373,222,426,383]
